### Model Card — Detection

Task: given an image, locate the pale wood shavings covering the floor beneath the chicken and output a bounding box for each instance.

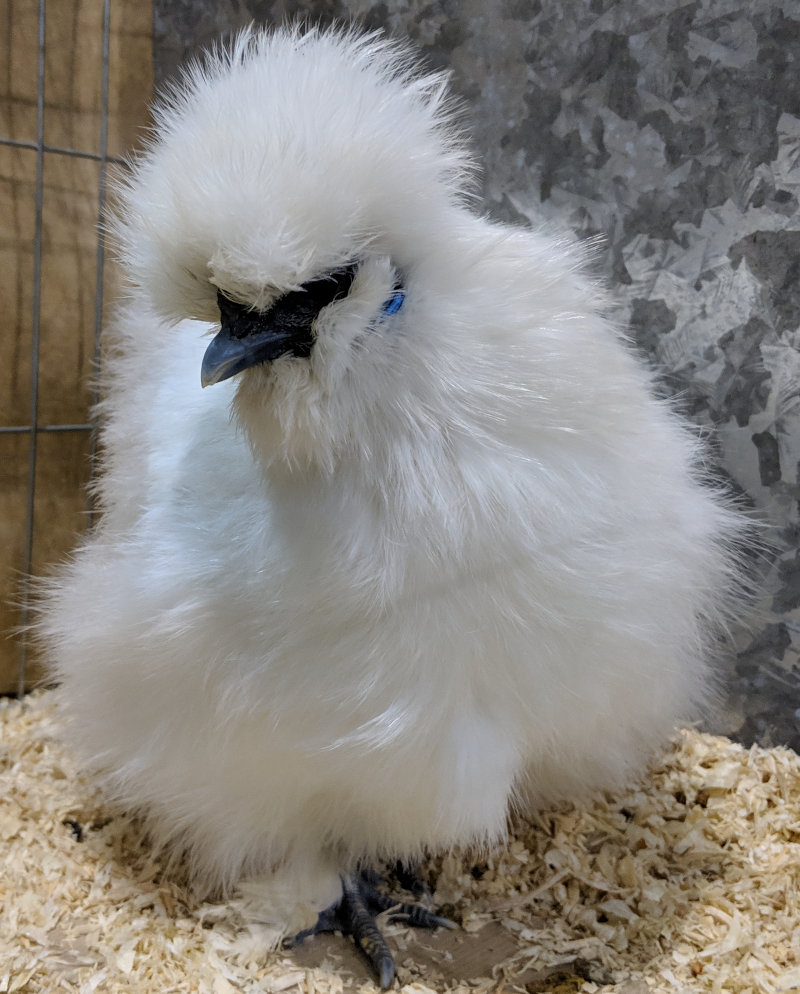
[0,691,800,994]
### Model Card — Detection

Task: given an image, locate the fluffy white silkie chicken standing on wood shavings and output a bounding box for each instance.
[41,23,739,985]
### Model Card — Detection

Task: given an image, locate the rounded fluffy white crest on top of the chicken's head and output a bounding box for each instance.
[113,27,476,320]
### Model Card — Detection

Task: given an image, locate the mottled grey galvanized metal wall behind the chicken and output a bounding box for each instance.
[154,0,800,748]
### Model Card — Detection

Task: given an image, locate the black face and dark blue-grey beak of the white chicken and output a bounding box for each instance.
[201,264,358,386]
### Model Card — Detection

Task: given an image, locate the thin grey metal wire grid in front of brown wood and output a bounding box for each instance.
[0,0,122,696]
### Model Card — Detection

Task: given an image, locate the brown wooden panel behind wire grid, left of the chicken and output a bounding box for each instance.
[0,0,152,692]
